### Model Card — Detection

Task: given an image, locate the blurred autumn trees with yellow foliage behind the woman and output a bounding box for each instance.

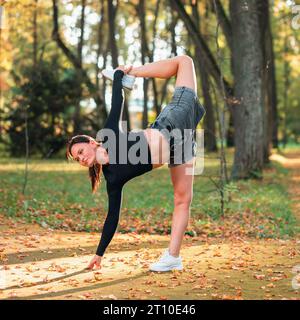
[0,0,300,179]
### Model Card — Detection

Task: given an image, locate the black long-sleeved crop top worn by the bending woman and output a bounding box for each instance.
[96,70,153,256]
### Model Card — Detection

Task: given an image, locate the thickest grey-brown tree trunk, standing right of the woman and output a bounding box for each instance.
[230,0,263,179]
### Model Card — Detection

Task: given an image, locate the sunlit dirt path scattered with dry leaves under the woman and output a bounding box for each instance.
[0,155,300,300]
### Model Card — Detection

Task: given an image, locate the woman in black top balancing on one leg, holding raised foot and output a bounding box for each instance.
[67,55,205,271]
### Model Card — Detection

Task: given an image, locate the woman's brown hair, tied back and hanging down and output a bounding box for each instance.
[66,134,102,193]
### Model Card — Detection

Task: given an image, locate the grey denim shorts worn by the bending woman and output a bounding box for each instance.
[149,87,205,167]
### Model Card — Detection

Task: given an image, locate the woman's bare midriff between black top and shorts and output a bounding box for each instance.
[143,128,170,169]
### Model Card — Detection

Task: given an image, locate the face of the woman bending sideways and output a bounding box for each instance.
[71,141,97,167]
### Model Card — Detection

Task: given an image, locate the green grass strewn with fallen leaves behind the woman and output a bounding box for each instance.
[0,152,296,237]
